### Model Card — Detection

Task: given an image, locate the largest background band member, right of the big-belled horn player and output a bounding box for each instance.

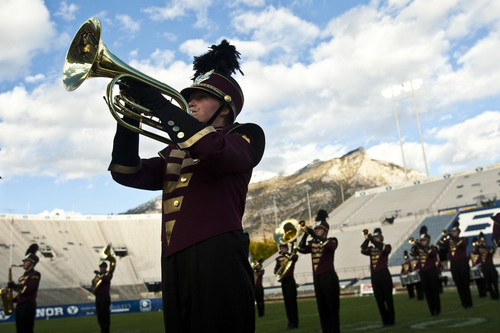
[298,209,340,333]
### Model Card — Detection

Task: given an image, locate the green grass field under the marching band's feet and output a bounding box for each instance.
[0,288,500,333]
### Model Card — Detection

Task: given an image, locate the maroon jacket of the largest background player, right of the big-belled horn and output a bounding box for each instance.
[298,237,338,275]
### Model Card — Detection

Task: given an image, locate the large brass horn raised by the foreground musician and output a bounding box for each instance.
[62,17,191,145]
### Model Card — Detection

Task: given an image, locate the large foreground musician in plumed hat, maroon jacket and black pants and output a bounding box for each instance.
[109,40,265,332]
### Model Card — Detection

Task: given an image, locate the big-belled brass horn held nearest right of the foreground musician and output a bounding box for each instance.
[274,219,300,282]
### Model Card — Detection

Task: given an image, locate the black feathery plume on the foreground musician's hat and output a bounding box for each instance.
[193,39,243,80]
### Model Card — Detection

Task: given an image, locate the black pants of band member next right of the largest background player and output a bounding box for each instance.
[371,268,394,325]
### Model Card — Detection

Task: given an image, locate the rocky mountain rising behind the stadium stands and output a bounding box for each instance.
[125,148,425,240]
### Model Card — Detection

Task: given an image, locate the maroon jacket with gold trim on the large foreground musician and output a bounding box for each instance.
[110,123,263,257]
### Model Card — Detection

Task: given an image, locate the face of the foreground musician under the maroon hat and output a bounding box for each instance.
[188,90,229,127]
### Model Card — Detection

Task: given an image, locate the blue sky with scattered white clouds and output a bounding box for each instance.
[0,0,500,214]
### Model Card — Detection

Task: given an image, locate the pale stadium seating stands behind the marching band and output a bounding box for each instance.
[0,163,500,305]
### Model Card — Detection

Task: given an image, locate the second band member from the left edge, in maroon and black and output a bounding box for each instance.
[92,261,116,333]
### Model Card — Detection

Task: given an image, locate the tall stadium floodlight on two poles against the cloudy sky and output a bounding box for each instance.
[382,79,429,180]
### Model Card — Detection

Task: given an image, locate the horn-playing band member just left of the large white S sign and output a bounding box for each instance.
[439,221,472,309]
